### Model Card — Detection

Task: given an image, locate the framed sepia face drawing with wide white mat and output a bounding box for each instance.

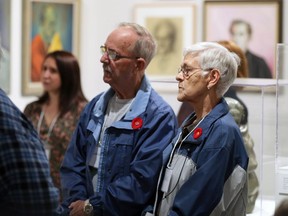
[133,2,197,81]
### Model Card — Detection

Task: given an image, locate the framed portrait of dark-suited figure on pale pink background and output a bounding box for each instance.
[204,0,282,78]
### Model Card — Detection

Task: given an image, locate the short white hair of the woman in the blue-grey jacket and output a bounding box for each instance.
[183,42,240,97]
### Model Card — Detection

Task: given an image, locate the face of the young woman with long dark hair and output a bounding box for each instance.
[41,57,61,92]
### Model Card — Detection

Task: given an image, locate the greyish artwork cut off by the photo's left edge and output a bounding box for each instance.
[0,0,11,94]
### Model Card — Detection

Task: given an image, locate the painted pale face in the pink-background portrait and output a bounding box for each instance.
[231,23,250,52]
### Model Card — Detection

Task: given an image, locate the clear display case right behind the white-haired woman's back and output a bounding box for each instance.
[234,78,277,216]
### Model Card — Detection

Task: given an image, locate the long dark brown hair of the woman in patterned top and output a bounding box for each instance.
[38,50,87,116]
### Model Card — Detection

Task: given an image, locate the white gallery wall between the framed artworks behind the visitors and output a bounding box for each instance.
[9,0,288,111]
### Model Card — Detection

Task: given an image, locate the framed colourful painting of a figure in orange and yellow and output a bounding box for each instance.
[22,0,80,95]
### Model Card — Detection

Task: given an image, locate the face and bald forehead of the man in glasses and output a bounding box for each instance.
[100,27,140,91]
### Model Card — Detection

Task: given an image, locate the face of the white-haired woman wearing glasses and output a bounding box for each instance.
[176,53,208,102]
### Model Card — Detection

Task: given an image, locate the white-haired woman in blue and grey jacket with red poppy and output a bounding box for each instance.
[146,42,248,216]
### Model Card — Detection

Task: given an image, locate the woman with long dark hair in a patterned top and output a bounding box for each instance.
[24,51,87,200]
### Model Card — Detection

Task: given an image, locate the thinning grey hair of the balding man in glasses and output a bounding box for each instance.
[119,22,157,67]
